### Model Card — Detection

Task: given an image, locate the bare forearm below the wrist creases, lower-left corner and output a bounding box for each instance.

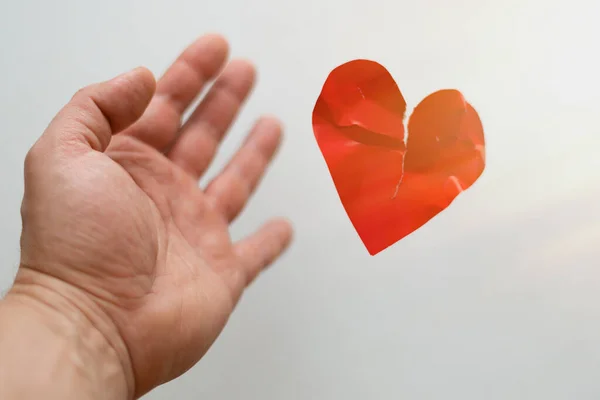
[0,286,128,400]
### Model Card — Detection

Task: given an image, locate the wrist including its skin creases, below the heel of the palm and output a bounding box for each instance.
[0,267,134,400]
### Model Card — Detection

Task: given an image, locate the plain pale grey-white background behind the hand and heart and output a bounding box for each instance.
[0,0,600,400]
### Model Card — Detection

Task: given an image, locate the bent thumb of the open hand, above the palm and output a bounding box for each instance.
[41,67,156,152]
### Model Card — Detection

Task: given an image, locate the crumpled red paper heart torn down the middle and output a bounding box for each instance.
[313,60,485,255]
